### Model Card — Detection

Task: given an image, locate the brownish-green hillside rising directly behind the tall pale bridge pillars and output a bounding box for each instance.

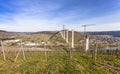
[18,31,83,44]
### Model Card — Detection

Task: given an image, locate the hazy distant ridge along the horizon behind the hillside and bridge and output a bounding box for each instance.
[0,30,120,39]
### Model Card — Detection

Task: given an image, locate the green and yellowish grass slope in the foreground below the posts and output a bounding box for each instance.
[0,52,120,74]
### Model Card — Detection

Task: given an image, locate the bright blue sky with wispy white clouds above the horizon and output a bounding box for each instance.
[0,0,120,32]
